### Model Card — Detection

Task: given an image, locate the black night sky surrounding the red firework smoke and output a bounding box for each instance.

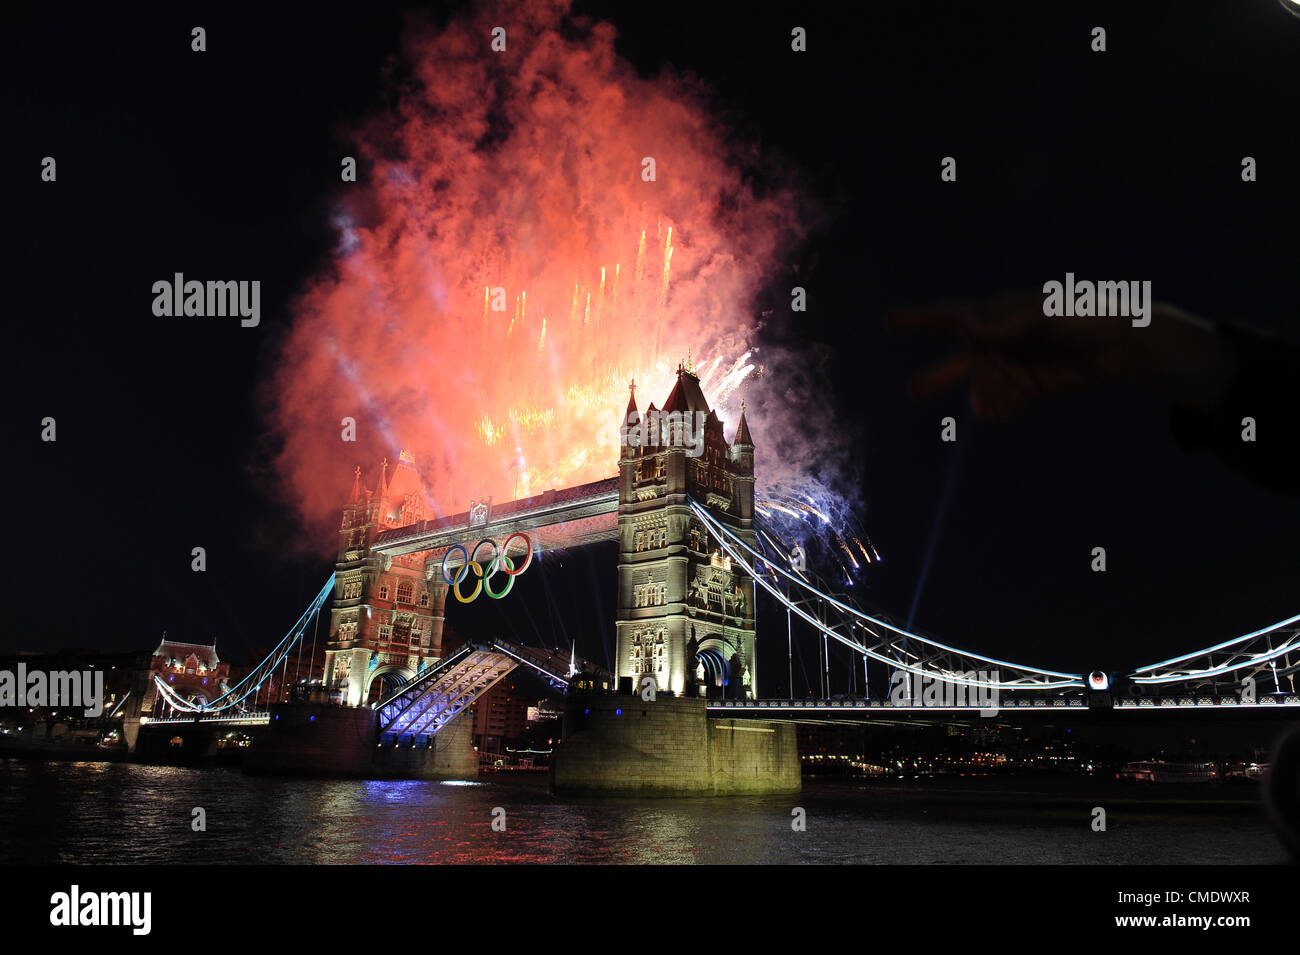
[0,0,1300,685]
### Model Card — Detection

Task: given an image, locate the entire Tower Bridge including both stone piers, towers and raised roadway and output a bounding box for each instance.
[129,364,1300,795]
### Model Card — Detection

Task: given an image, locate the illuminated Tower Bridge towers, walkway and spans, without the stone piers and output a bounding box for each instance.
[139,368,1300,745]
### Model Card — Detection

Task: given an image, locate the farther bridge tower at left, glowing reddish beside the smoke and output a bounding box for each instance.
[325,451,447,706]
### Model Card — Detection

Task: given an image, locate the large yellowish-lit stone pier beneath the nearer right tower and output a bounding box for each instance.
[550,693,801,796]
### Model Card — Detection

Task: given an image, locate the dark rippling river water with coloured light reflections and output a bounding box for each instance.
[0,760,1284,864]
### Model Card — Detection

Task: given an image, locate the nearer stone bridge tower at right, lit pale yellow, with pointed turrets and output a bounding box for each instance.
[615,363,758,699]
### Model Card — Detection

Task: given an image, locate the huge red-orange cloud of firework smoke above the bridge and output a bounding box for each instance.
[269,1,857,553]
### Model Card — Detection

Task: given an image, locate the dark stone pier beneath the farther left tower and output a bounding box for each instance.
[244,703,478,780]
